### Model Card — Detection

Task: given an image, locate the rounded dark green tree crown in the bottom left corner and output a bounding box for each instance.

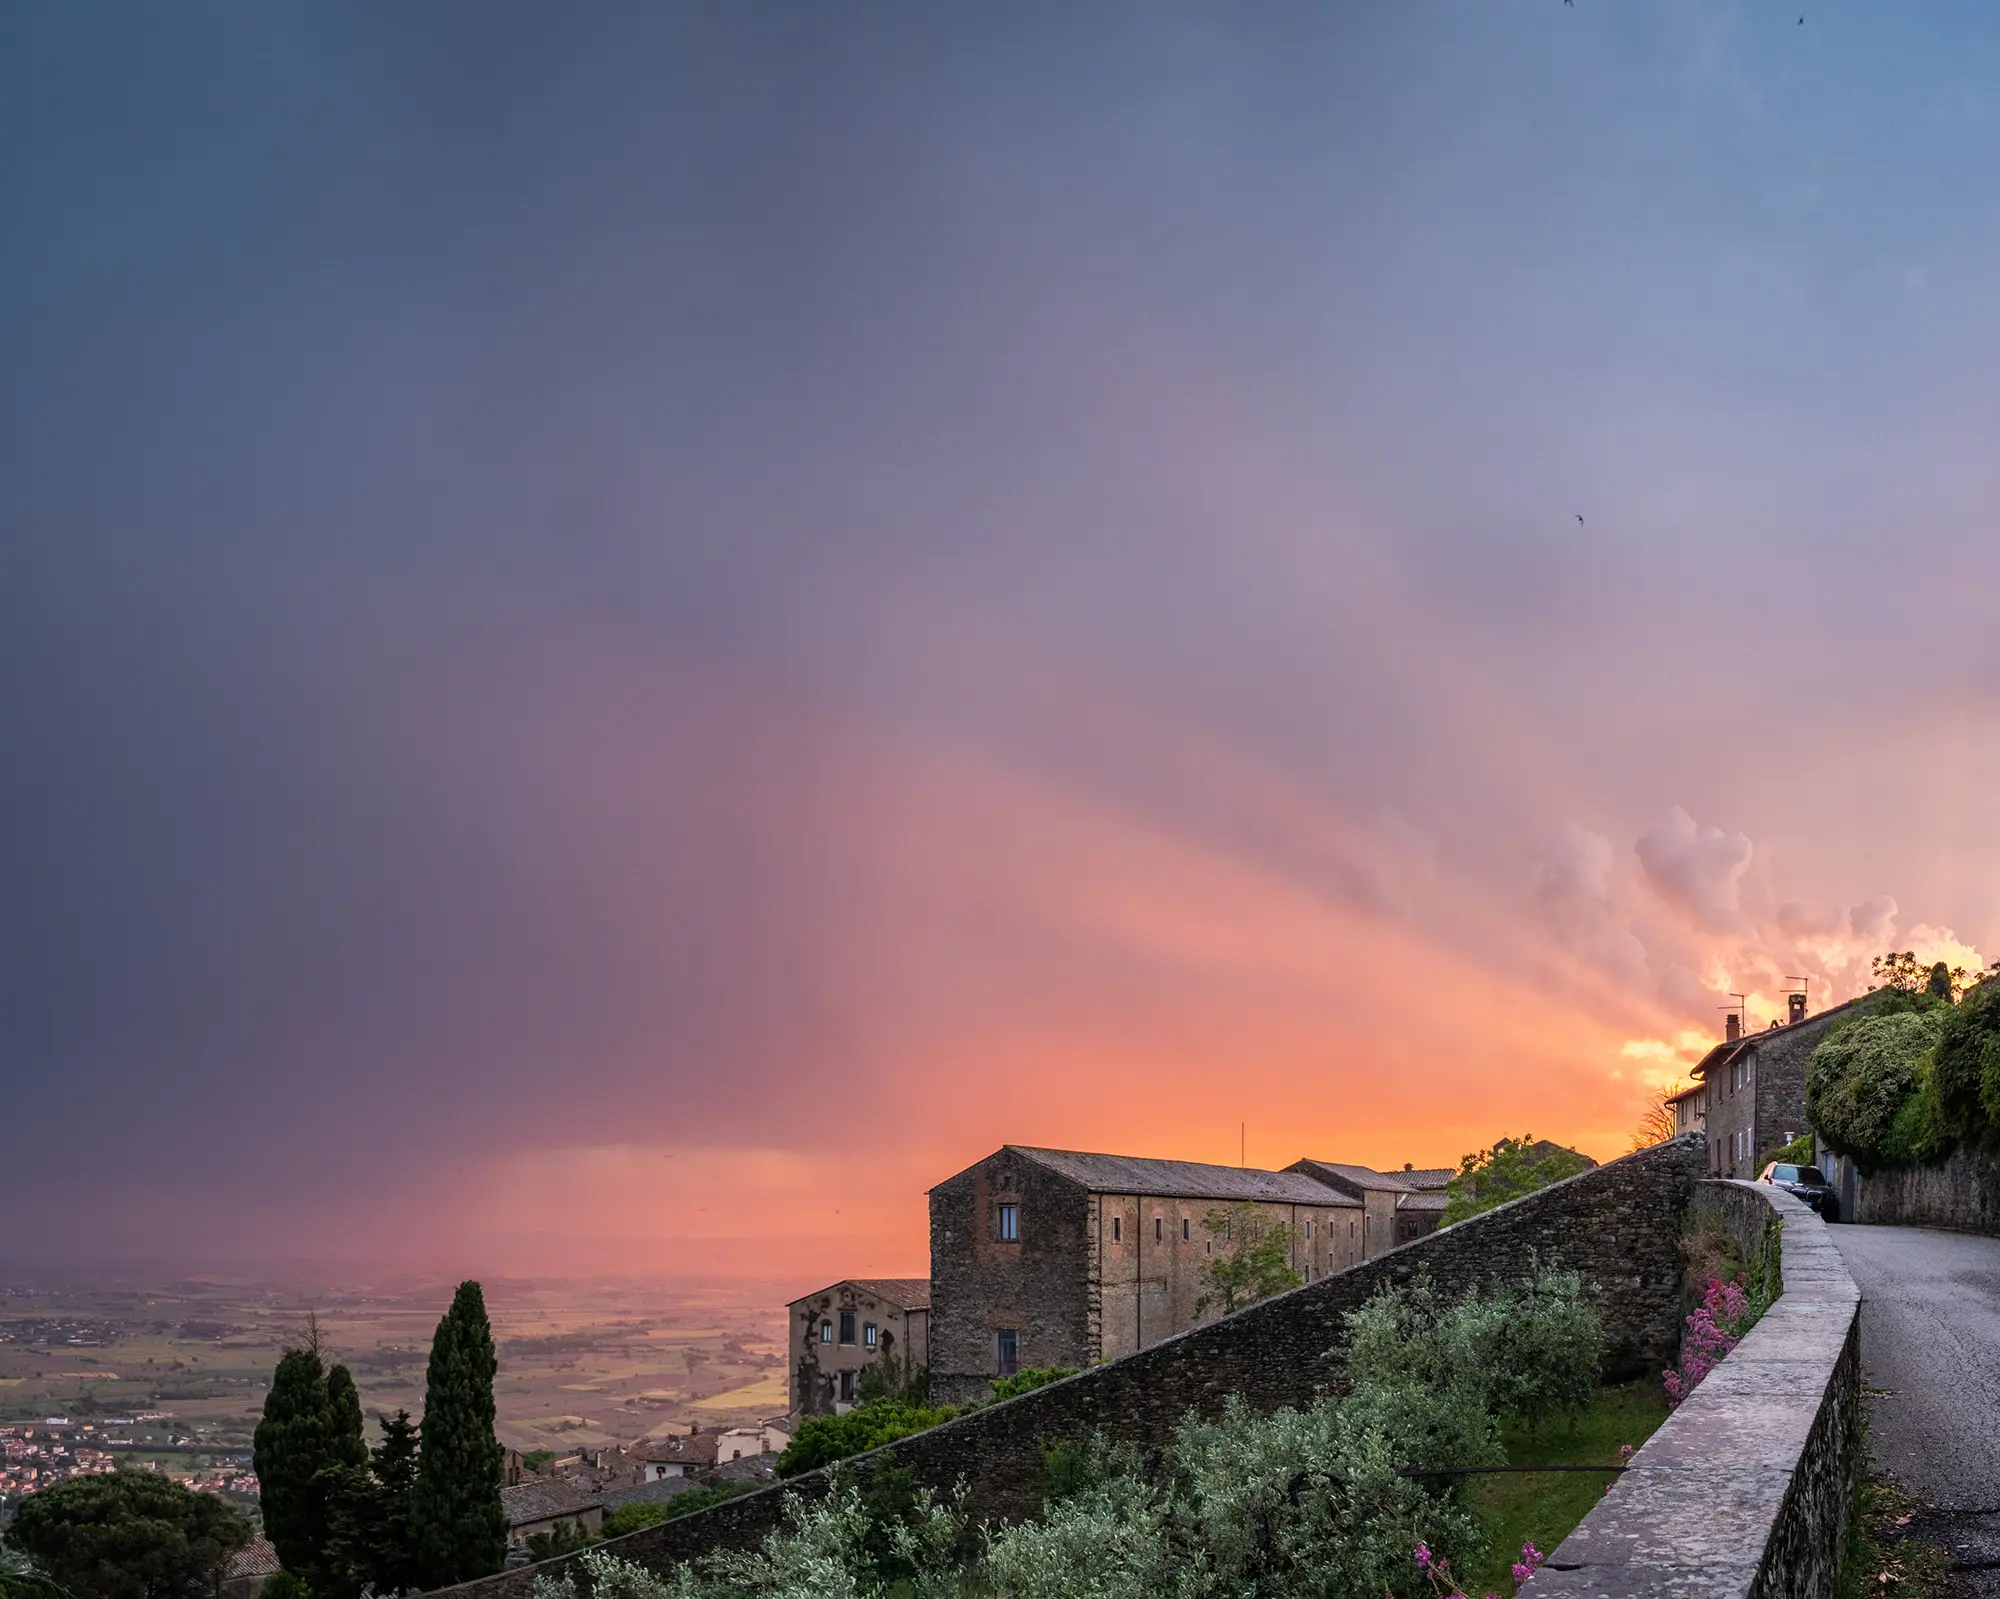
[6,1471,250,1599]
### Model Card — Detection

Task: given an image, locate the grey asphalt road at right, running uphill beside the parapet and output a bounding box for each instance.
[1826,1227,2000,1593]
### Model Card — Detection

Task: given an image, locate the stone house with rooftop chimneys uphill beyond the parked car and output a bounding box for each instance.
[1674,993,1876,1177]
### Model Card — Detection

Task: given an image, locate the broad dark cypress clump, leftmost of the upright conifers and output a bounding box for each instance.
[252,1325,368,1599]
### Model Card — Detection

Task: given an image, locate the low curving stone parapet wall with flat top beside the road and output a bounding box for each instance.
[1522,1181,1862,1599]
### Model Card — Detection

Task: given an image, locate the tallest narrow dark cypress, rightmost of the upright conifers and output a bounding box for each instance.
[410,1283,506,1587]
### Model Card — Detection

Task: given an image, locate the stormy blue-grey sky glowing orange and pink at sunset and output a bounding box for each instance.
[0,0,2000,1281]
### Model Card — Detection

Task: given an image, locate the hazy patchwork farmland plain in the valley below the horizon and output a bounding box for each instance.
[0,1277,786,1449]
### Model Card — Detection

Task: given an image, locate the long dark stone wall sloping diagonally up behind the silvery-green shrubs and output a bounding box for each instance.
[438,1137,1714,1599]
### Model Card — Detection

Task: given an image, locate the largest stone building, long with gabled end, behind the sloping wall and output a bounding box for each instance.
[930,1145,1362,1401]
